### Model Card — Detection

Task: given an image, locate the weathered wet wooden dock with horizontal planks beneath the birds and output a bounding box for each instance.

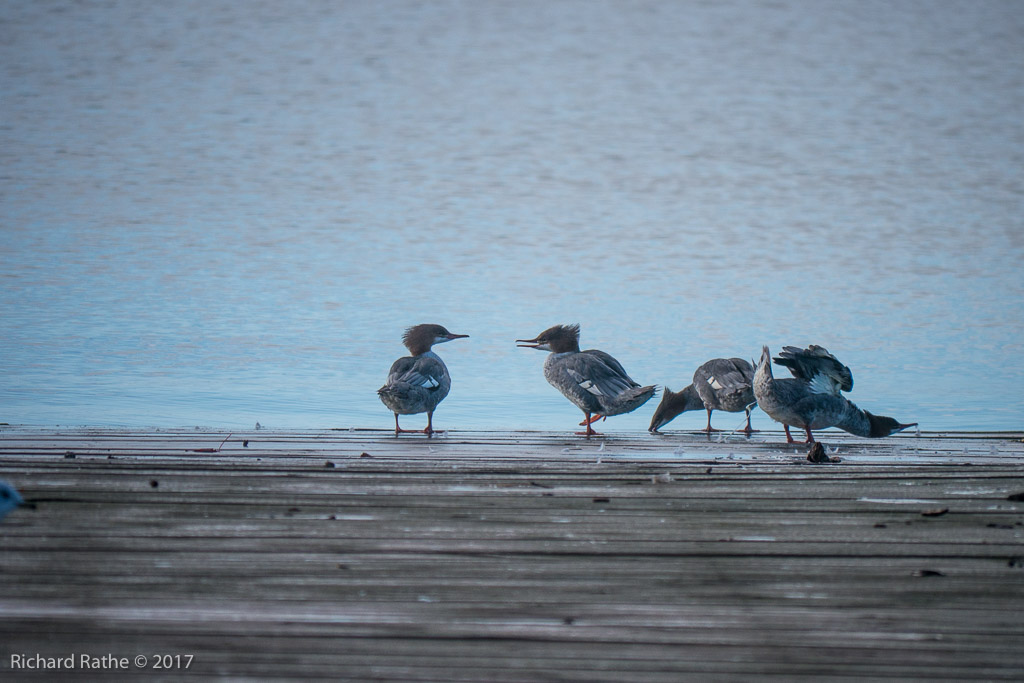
[0,427,1024,683]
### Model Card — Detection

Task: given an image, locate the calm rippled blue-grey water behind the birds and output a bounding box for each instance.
[0,0,1024,431]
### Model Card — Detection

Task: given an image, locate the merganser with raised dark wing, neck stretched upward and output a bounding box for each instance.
[754,345,918,443]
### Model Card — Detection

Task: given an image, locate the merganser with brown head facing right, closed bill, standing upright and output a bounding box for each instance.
[377,325,469,436]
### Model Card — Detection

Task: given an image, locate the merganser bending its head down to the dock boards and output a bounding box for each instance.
[647,358,757,434]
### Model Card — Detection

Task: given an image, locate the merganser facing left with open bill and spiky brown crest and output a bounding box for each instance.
[516,325,655,436]
